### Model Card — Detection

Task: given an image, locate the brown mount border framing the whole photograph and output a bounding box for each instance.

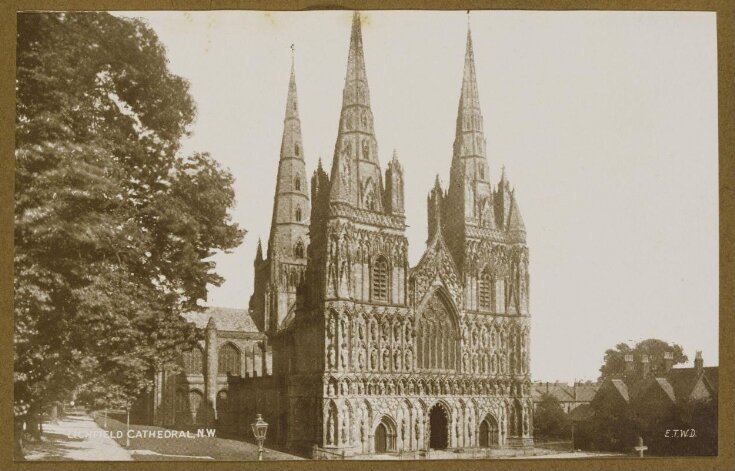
[0,0,735,471]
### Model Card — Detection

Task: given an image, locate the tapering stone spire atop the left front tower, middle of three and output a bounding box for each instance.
[330,12,383,212]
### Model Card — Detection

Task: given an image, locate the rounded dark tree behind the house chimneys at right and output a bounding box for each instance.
[599,339,688,381]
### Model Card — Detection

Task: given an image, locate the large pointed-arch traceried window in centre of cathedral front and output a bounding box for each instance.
[416,290,459,370]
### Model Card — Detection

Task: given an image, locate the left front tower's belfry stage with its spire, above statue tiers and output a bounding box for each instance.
[315,13,408,304]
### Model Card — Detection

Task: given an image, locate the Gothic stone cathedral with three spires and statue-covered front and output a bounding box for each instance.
[243,13,533,458]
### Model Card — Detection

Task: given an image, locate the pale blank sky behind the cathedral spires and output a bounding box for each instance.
[118,11,719,381]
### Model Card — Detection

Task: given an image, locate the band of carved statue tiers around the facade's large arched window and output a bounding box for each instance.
[325,306,529,375]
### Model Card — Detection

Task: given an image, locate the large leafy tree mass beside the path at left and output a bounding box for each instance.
[14,13,244,460]
